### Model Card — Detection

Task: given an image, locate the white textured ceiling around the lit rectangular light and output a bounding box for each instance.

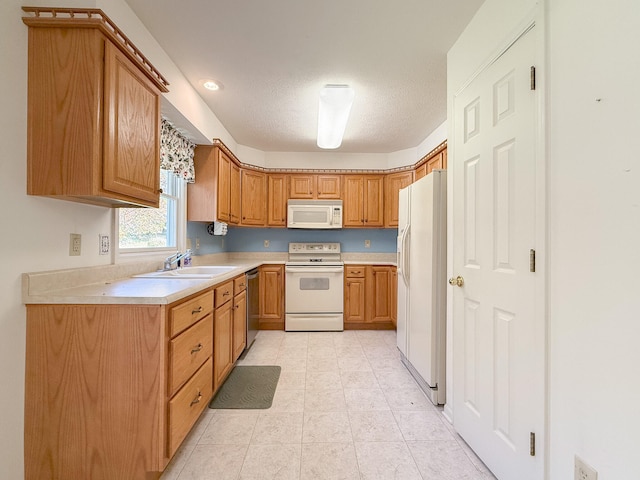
[126,0,483,153]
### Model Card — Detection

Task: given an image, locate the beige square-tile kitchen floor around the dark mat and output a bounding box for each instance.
[161,331,494,480]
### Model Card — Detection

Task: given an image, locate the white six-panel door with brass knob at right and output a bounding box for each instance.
[450,23,545,480]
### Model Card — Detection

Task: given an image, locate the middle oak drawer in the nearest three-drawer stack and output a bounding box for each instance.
[169,315,213,395]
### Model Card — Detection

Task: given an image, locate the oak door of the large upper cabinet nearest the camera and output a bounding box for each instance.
[102,42,160,207]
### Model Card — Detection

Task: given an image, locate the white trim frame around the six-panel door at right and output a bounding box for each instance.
[443,0,550,479]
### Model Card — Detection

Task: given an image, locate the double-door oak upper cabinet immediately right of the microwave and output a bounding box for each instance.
[343,175,384,227]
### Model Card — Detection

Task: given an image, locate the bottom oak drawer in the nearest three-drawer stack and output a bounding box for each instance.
[167,358,213,457]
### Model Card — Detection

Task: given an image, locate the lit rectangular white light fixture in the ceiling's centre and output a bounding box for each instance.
[318,85,355,149]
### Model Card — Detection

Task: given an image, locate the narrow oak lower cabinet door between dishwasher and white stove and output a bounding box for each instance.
[259,265,284,330]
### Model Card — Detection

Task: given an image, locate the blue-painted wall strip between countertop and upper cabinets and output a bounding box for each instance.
[187,222,398,255]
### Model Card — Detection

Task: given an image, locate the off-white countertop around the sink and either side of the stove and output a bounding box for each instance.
[22,252,395,305]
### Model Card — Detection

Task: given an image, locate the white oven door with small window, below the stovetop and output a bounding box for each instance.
[285,265,344,314]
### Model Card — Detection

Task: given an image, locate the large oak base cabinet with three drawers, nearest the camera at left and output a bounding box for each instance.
[24,289,213,480]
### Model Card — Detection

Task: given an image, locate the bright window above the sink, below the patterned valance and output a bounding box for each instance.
[118,170,186,253]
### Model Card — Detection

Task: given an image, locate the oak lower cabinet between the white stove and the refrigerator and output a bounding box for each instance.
[344,265,396,330]
